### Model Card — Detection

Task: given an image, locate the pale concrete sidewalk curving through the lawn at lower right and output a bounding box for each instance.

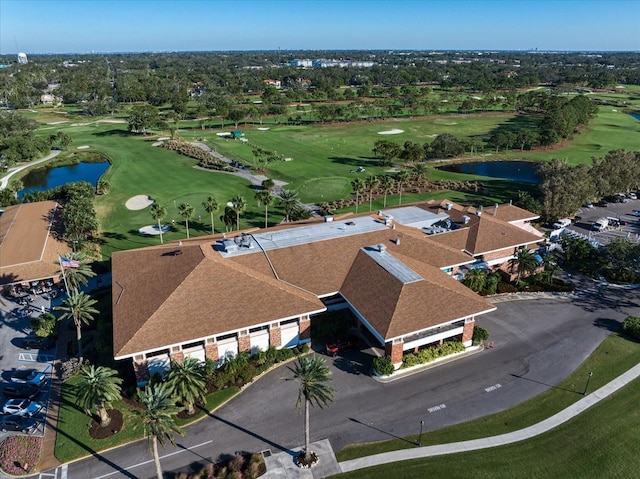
[342,364,640,477]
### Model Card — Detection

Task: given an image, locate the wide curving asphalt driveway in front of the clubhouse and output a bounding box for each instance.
[56,284,640,479]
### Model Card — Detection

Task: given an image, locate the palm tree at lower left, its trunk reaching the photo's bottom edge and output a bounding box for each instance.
[131,383,184,479]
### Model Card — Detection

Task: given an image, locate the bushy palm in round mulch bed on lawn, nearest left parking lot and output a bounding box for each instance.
[76,365,122,427]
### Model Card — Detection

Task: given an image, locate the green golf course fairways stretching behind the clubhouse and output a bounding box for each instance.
[22,94,640,259]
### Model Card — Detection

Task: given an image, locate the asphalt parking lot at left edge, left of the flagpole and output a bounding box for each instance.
[0,296,55,442]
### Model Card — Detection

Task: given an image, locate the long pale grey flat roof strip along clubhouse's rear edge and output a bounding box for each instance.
[216,216,388,258]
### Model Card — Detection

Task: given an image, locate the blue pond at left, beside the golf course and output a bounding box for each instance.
[18,161,109,198]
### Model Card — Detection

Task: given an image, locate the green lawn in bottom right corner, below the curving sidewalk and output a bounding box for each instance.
[331,381,640,479]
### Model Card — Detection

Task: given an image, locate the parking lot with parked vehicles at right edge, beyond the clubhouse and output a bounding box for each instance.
[565,200,640,246]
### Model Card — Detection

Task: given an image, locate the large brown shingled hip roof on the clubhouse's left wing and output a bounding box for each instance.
[112,244,324,357]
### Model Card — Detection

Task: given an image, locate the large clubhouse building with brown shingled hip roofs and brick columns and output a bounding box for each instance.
[112,201,541,382]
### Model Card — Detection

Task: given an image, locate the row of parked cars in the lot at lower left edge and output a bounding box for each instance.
[0,369,47,434]
